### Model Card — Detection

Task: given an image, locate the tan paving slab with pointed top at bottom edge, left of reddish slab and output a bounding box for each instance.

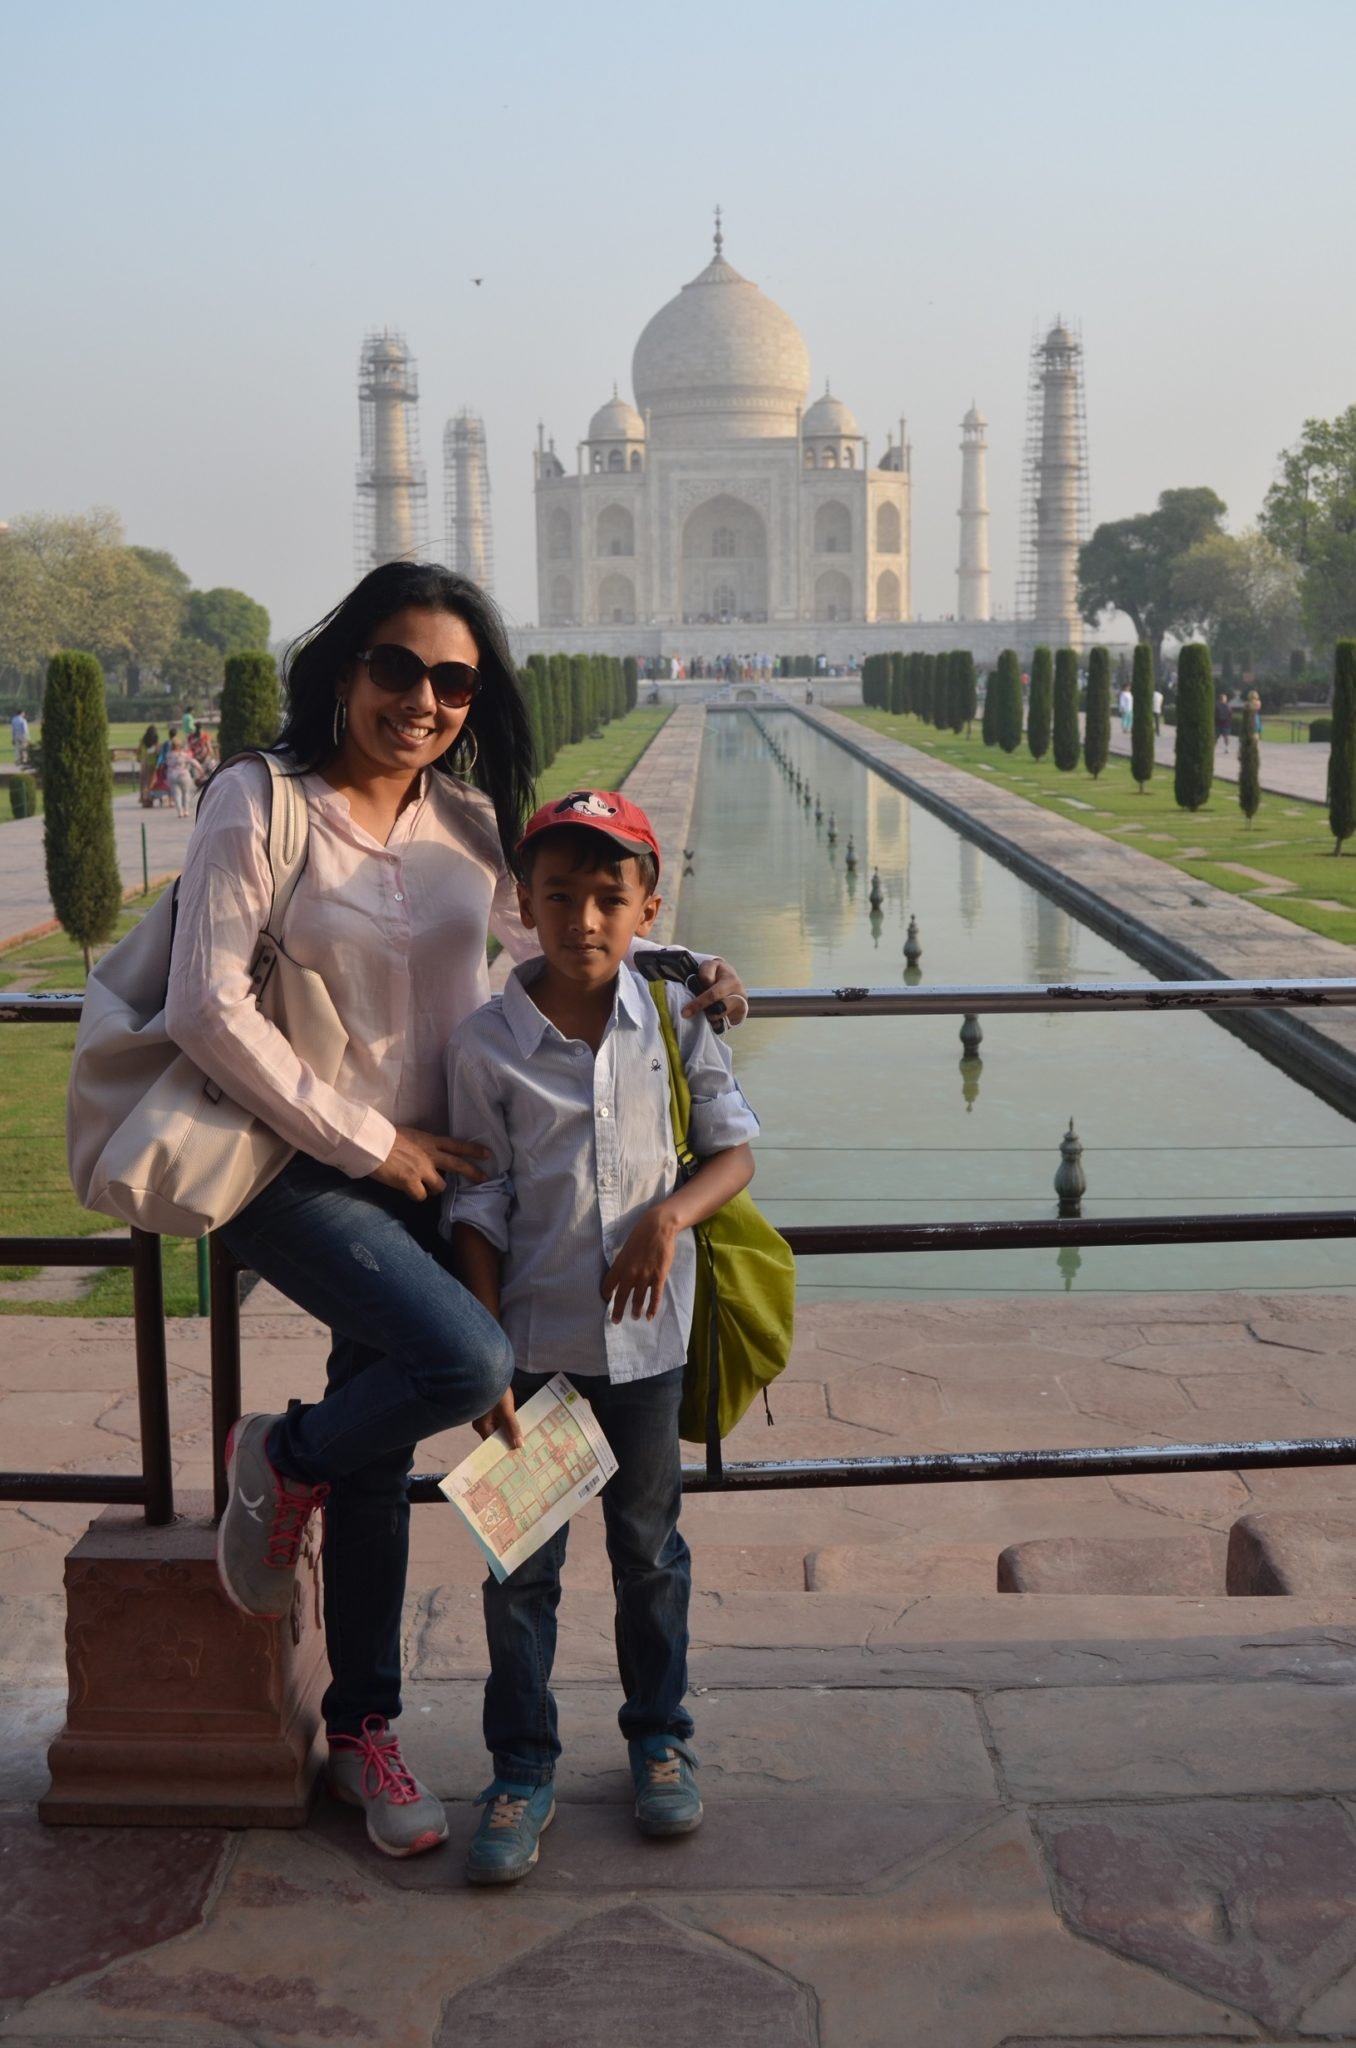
[704,1815,1256,2048]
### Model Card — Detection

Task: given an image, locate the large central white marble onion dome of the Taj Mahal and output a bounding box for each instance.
[631,242,809,446]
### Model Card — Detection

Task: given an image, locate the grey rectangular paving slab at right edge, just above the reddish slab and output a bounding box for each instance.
[985,1679,1356,1800]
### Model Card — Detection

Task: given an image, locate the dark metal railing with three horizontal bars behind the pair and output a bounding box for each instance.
[0,979,1356,1522]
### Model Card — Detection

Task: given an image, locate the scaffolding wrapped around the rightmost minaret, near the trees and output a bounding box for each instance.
[1016,317,1092,645]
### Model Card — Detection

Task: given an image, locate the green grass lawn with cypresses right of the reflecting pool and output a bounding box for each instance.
[848,709,1356,944]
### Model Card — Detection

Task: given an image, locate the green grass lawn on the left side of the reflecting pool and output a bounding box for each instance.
[0,705,670,1315]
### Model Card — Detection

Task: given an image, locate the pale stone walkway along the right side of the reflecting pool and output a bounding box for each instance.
[811,707,1356,1114]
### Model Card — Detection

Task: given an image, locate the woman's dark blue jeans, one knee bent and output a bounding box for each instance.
[221,1153,512,1735]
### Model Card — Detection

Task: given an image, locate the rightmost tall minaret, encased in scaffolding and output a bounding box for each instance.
[1032,319,1086,647]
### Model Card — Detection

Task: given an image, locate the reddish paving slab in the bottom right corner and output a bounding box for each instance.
[1036,1798,1356,2028]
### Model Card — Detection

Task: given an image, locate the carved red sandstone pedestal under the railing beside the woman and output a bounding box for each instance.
[39,1493,328,1827]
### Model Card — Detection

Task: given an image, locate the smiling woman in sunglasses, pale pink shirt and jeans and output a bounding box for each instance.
[166,563,741,1855]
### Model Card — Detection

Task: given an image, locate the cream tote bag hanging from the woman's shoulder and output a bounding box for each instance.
[66,754,348,1237]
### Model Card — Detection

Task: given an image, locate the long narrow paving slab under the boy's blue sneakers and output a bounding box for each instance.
[309,1794,1002,1898]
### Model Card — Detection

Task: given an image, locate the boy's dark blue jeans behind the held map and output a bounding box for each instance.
[483,1368,692,1786]
